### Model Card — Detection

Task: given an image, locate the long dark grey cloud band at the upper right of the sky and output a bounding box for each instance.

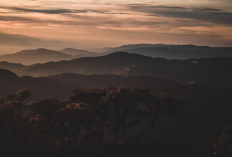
[128,4,232,25]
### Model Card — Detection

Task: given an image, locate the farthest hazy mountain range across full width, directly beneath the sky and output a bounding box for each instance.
[0,44,232,65]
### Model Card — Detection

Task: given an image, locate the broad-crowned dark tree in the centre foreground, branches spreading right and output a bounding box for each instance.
[68,87,187,143]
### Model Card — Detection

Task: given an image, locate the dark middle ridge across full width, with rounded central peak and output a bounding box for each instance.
[0,52,232,86]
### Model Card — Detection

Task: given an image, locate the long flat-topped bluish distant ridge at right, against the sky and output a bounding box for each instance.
[93,44,232,60]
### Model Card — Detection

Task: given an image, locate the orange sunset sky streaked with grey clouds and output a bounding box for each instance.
[0,0,232,52]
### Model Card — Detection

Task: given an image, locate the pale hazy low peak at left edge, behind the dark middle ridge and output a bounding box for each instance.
[0,48,76,65]
